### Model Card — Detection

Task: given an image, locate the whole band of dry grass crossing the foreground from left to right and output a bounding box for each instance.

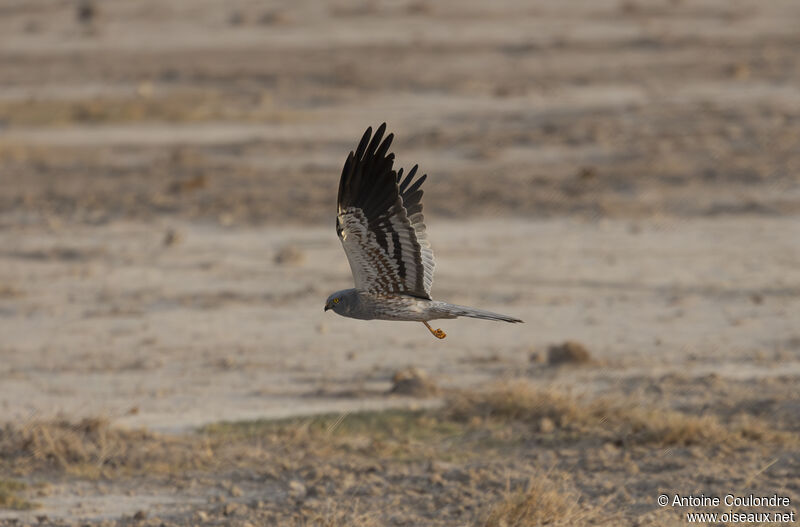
[0,382,784,478]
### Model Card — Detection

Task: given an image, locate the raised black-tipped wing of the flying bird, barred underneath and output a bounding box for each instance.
[336,123,434,299]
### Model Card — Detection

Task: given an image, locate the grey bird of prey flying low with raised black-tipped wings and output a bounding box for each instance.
[325,123,522,339]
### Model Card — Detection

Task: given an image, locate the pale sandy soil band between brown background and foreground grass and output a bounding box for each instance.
[0,216,800,431]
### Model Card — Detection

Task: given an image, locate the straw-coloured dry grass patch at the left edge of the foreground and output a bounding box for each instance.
[0,419,212,478]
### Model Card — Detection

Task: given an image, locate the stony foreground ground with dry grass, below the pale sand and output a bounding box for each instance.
[0,382,800,527]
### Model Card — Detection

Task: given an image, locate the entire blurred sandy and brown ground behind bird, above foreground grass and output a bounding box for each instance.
[0,0,800,524]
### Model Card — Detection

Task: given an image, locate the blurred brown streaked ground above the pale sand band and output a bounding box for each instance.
[0,0,800,225]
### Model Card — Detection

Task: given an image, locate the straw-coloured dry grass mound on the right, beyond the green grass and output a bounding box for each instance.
[445,381,797,446]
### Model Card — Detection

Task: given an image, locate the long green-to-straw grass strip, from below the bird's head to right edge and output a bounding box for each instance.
[200,382,797,461]
